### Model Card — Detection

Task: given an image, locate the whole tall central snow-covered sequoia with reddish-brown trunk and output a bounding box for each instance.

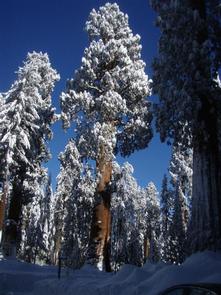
[61,3,152,270]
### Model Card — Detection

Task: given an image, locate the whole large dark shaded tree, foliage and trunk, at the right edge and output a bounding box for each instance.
[151,0,221,252]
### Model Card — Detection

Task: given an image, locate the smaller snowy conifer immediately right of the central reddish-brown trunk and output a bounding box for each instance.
[111,163,147,270]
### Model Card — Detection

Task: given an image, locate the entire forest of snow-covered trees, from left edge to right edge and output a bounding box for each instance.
[0,0,221,271]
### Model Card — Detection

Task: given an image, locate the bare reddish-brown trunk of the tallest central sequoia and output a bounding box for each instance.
[88,157,112,271]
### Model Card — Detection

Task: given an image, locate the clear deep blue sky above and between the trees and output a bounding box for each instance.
[0,0,170,189]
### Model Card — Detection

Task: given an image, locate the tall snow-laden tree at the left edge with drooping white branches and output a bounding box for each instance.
[0,52,59,254]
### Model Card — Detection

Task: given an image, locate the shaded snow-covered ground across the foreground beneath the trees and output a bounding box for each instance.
[0,251,221,295]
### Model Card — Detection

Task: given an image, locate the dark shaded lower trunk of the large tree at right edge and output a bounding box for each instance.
[189,99,221,252]
